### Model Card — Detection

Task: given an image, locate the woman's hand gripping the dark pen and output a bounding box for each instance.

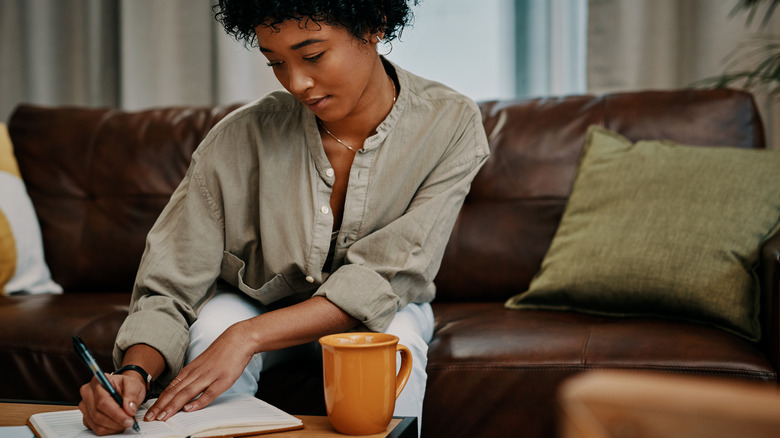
[79,376,137,435]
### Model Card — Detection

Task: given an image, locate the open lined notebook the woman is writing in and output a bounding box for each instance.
[27,394,303,438]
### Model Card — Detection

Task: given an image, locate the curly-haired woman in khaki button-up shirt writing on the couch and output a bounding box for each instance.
[79,0,488,434]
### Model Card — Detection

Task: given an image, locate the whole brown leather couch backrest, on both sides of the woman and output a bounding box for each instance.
[9,90,764,301]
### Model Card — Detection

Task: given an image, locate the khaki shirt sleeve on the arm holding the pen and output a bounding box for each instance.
[114,152,224,384]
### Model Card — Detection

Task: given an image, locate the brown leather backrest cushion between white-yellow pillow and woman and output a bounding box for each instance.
[8,105,241,293]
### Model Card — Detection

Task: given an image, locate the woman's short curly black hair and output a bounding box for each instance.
[213,0,419,46]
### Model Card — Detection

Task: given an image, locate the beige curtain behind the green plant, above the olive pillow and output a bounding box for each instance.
[587,0,780,149]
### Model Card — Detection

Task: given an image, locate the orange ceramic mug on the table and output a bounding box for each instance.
[320,332,412,435]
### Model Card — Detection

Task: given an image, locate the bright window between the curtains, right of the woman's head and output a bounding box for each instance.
[380,0,587,100]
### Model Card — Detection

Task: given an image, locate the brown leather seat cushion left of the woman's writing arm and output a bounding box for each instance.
[0,292,130,402]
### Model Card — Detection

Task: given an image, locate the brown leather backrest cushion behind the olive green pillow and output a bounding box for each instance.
[436,89,764,301]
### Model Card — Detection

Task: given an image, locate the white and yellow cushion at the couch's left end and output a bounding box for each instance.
[0,123,62,295]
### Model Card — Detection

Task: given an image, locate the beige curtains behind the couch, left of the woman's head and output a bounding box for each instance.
[0,0,279,122]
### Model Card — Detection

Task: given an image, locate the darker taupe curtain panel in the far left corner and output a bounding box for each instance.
[0,0,118,121]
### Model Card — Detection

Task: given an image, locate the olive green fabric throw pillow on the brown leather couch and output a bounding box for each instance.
[506,126,780,341]
